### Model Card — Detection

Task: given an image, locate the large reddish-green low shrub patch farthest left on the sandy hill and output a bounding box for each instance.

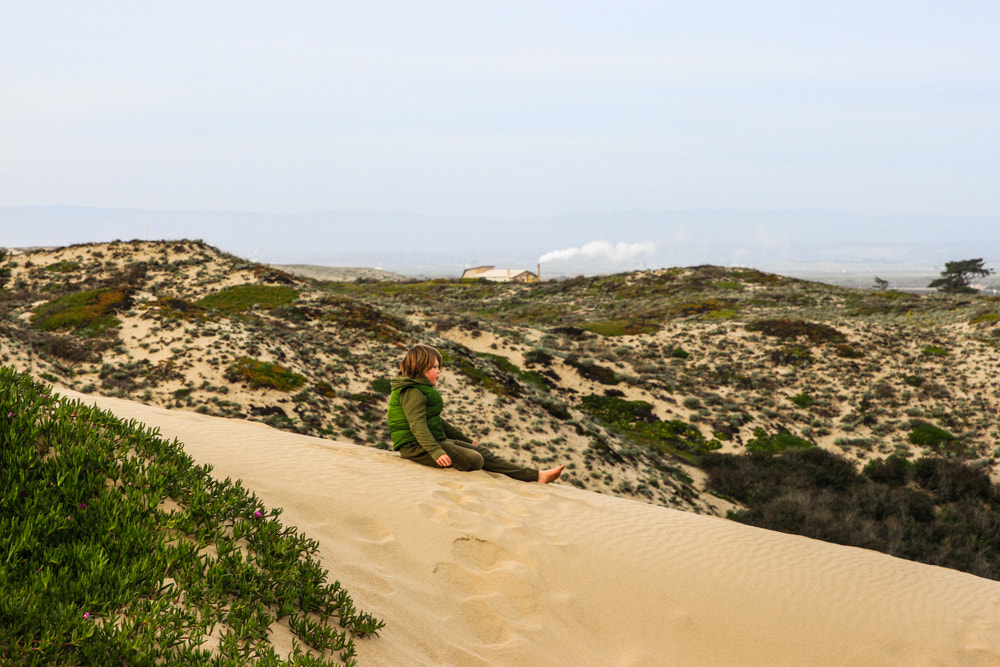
[31,288,132,337]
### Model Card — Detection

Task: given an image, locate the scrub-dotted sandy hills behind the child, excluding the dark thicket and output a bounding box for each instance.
[0,241,1000,576]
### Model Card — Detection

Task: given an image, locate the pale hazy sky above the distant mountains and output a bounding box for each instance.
[0,0,1000,220]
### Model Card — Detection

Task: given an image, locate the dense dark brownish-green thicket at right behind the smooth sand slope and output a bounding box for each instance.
[702,447,1000,579]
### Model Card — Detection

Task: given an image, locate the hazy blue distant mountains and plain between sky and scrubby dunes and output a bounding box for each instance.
[0,206,1000,276]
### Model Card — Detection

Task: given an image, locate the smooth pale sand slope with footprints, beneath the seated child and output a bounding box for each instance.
[61,390,1000,667]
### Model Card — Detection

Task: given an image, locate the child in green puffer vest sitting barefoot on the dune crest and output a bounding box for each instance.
[388,345,566,484]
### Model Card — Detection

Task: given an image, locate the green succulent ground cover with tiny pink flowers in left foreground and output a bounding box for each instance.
[0,367,382,665]
